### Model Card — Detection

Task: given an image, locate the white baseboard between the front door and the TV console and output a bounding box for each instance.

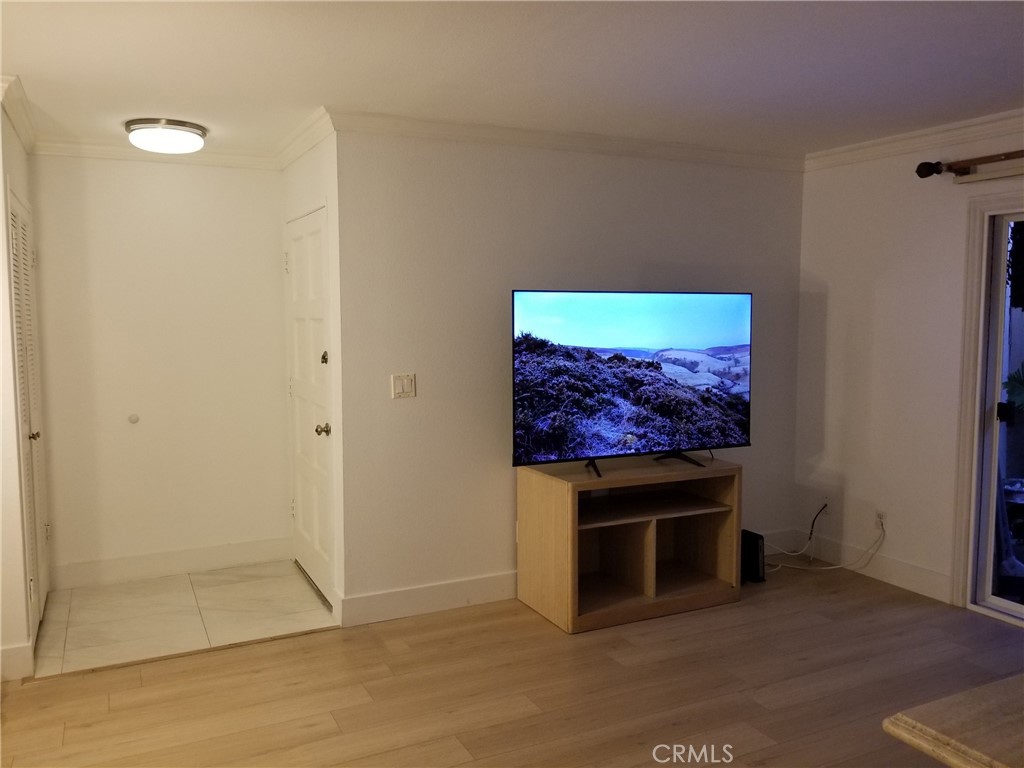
[341,570,516,627]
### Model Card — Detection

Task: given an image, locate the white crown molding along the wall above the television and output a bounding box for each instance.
[330,113,804,173]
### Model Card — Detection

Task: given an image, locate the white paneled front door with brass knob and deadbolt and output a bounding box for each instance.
[286,209,338,600]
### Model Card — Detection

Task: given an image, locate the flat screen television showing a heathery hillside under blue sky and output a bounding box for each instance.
[512,291,752,469]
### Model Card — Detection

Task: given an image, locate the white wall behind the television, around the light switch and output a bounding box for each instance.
[339,134,801,623]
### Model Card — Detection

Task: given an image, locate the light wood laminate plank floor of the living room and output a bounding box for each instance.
[0,569,1024,768]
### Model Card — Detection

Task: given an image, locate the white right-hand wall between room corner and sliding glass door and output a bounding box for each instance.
[797,128,1022,601]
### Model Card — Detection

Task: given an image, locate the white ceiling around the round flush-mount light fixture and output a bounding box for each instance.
[0,0,1024,163]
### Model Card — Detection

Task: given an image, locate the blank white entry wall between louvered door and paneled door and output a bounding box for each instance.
[33,156,290,588]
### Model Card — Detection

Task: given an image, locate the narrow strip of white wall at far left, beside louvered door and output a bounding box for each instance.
[0,112,35,680]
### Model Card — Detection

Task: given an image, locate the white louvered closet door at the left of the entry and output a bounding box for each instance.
[7,193,49,633]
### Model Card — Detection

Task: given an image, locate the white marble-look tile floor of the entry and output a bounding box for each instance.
[36,560,335,678]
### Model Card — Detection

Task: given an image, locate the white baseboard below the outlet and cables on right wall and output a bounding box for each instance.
[762,530,952,603]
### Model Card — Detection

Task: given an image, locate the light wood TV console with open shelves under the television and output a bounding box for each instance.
[516,457,742,632]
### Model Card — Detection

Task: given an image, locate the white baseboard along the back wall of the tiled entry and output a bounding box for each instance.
[50,539,292,590]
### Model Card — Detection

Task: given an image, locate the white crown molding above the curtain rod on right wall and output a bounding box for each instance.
[804,110,1024,171]
